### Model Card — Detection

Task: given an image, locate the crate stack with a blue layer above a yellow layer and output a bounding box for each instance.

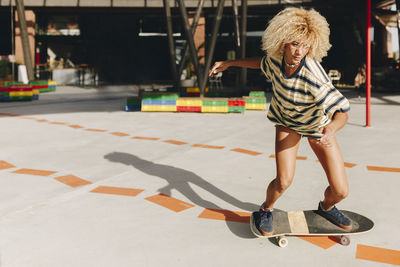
[142,93,179,112]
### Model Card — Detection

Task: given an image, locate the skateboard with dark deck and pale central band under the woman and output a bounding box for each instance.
[250,210,374,247]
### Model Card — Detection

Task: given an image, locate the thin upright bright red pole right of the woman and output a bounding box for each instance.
[365,0,371,127]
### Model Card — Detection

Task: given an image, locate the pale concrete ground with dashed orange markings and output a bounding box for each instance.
[0,87,400,267]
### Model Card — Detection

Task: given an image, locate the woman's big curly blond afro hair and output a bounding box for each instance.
[262,7,331,62]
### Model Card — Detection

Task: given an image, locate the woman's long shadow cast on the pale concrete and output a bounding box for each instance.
[104,152,259,238]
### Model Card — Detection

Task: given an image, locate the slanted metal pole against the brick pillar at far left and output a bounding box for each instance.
[16,0,35,81]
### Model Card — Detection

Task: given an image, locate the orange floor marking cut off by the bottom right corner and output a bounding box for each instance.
[356,245,400,265]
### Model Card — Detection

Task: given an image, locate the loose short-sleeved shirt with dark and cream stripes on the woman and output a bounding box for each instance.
[261,56,350,138]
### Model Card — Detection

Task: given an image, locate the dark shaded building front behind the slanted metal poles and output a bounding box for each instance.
[0,0,399,90]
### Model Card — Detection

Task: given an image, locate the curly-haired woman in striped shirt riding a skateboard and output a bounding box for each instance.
[210,7,352,236]
